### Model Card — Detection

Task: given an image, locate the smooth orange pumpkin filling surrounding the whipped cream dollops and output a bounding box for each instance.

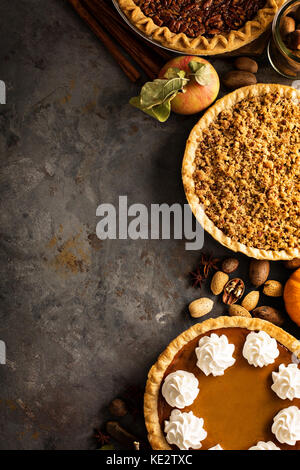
[158,328,300,450]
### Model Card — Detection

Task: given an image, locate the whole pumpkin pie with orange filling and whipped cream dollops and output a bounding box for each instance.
[144,316,300,450]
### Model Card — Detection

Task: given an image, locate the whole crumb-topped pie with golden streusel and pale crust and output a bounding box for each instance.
[182,84,300,260]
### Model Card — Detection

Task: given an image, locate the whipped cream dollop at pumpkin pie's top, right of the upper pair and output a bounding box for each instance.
[243,331,279,367]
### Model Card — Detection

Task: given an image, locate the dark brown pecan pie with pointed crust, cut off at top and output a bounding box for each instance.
[118,0,284,55]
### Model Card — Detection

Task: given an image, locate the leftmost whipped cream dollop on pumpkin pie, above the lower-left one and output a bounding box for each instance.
[161,370,199,408]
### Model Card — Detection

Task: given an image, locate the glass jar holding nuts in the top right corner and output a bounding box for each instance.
[268,0,300,79]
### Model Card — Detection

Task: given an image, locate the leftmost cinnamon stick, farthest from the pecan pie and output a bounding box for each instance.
[68,0,141,82]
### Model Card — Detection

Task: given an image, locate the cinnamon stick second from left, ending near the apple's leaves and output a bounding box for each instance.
[84,0,161,80]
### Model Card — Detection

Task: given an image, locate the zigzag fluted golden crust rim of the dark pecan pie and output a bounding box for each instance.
[118,0,285,55]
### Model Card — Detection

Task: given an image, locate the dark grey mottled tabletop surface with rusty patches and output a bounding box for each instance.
[0,0,299,449]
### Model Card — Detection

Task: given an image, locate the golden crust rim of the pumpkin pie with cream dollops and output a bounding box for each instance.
[144,316,300,450]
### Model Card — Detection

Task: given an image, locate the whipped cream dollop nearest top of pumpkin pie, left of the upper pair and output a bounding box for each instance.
[195,333,235,376]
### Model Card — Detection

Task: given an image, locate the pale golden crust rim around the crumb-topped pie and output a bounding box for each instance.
[182,83,300,261]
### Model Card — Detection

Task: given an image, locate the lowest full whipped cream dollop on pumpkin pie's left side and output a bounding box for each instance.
[165,410,207,450]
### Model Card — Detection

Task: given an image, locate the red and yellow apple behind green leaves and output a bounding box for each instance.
[159,56,220,114]
